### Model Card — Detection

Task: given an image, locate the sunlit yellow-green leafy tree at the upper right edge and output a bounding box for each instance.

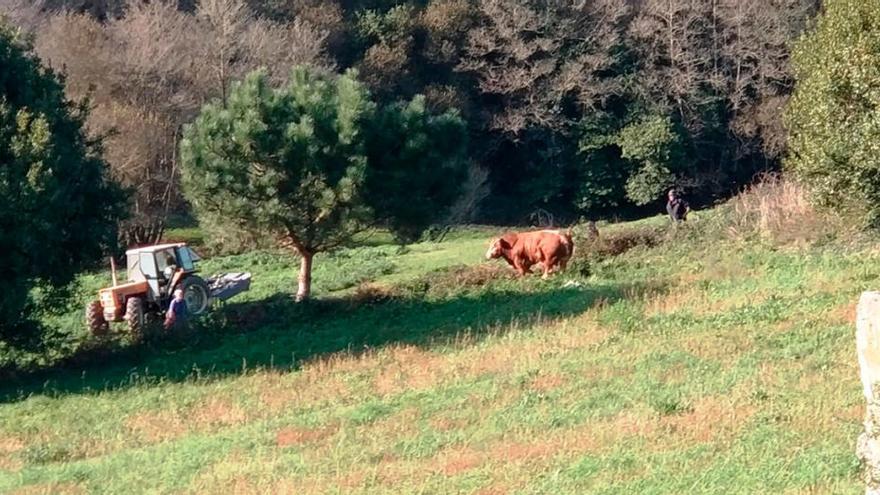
[785,0,880,223]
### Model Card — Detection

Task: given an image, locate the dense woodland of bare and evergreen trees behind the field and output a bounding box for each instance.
[0,0,818,243]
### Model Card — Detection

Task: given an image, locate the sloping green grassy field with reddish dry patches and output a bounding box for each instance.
[0,213,868,495]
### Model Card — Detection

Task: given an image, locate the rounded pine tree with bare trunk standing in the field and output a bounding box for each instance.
[181,67,464,300]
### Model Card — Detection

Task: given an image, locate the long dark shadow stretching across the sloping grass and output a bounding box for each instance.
[0,285,657,402]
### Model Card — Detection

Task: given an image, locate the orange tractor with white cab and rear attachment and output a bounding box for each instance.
[86,243,250,338]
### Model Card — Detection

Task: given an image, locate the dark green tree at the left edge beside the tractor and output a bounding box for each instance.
[0,20,123,339]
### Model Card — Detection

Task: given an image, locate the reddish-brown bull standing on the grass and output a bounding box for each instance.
[486,230,574,278]
